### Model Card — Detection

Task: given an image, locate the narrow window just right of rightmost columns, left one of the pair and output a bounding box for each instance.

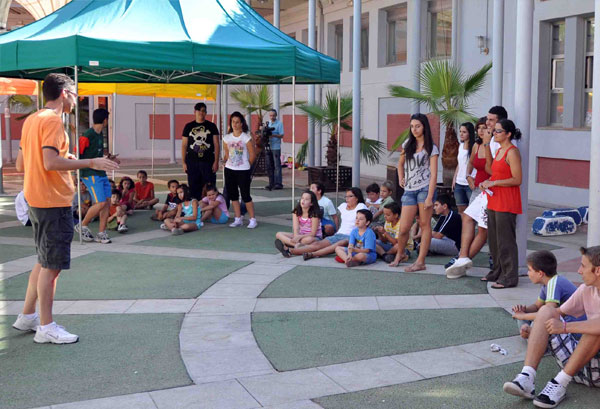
[550,21,565,126]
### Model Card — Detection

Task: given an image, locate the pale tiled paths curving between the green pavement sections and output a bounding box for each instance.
[0,163,592,409]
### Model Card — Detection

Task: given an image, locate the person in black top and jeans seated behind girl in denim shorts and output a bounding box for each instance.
[429,195,462,256]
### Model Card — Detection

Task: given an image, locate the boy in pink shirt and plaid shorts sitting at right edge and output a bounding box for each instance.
[504,246,600,408]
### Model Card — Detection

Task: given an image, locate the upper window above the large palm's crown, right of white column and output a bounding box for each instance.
[427,0,452,59]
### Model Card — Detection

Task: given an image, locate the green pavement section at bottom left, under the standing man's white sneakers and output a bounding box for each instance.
[0,314,192,409]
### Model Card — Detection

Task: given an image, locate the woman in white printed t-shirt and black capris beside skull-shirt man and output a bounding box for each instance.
[223,111,257,229]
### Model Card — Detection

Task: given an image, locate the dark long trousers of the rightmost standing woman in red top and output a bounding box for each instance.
[486,209,519,287]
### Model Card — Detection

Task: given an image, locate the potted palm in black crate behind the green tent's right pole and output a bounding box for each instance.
[296,91,385,191]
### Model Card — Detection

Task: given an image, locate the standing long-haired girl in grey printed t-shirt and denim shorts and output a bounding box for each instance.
[390,114,440,272]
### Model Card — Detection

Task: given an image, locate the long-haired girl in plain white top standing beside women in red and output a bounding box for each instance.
[452,122,475,216]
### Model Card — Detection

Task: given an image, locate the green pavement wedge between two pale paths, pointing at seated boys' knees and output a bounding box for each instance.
[252,308,517,371]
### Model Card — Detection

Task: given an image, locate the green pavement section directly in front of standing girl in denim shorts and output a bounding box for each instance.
[260,267,487,298]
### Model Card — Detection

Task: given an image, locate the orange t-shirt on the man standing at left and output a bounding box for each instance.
[20,109,75,208]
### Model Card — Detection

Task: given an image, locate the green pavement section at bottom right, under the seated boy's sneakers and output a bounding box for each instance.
[314,351,600,409]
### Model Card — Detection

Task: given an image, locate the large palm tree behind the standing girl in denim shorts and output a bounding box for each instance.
[389,60,492,185]
